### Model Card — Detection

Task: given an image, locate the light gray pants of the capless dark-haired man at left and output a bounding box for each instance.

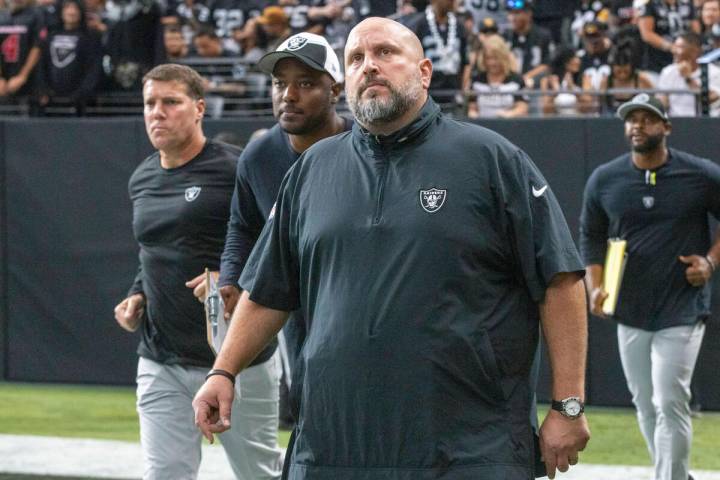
[137,354,282,480]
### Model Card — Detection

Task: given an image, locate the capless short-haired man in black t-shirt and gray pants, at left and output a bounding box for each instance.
[115,64,281,480]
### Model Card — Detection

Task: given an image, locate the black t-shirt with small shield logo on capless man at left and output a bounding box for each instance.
[128,140,240,367]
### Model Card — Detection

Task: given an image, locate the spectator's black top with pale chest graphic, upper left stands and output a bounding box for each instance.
[41,30,102,99]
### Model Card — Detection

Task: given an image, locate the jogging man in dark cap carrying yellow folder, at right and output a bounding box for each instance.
[580,93,720,480]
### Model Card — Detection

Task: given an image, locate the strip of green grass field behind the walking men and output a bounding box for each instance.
[0,383,720,468]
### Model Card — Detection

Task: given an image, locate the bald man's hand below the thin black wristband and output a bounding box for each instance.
[192,375,235,443]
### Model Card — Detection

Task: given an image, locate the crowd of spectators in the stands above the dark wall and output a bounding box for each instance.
[0,0,720,118]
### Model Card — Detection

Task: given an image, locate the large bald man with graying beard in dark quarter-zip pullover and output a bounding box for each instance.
[194,18,589,480]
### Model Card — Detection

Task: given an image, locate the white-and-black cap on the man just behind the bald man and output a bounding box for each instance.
[258,32,343,83]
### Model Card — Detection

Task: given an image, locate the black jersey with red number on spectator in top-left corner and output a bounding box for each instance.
[0,7,45,84]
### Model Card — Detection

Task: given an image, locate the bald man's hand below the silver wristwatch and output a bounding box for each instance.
[540,410,590,479]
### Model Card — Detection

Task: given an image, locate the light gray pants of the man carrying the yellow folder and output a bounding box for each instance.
[618,322,705,480]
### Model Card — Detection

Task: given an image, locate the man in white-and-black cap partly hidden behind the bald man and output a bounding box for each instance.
[188,33,352,434]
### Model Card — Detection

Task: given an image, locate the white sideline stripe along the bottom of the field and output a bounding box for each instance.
[0,435,720,480]
